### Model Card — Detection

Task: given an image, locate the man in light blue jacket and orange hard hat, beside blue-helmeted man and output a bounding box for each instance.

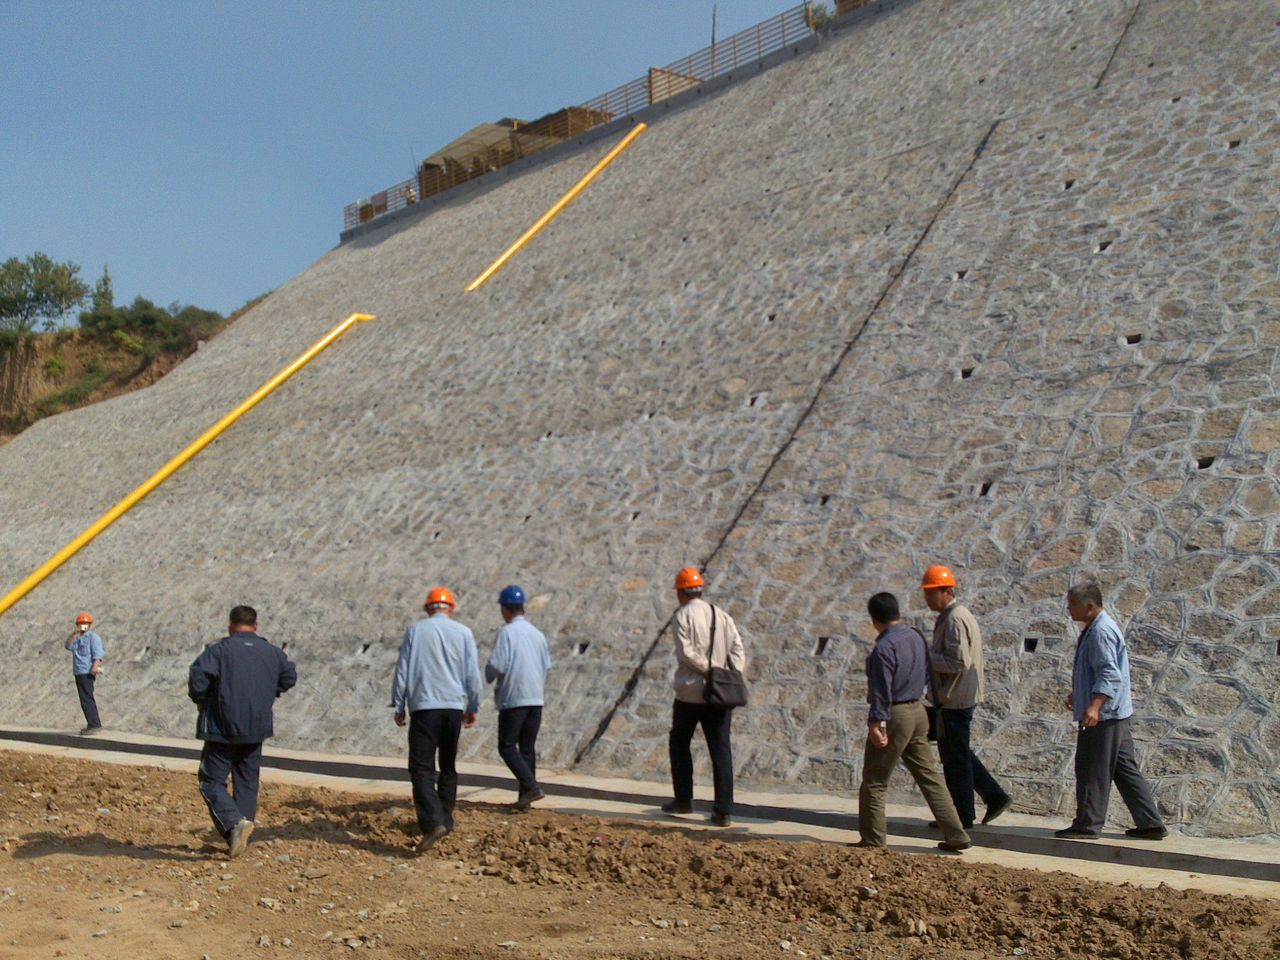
[392,586,484,852]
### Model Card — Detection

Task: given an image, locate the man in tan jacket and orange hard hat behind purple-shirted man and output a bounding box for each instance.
[920,563,1011,829]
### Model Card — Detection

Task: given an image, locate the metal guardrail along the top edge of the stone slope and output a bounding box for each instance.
[342,3,814,230]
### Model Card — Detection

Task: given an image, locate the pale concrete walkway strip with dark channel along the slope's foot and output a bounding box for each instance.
[0,727,1280,899]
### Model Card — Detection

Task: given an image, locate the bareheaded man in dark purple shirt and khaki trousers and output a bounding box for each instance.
[854,593,973,850]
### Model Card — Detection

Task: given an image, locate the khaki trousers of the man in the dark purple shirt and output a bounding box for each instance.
[858,700,969,846]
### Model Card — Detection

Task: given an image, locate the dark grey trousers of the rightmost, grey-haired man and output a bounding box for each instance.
[1071,717,1165,833]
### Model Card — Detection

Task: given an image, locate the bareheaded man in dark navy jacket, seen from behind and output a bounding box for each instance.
[187,607,298,856]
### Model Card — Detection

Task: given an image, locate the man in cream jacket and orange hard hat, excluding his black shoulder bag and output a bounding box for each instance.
[662,567,746,827]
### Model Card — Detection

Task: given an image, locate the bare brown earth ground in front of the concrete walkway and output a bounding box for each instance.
[0,751,1280,960]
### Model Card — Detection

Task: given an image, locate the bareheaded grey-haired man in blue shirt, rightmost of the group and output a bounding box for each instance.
[1055,580,1169,840]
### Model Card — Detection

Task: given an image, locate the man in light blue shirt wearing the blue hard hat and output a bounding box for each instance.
[484,584,552,810]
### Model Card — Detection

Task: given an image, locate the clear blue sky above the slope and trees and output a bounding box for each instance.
[0,0,795,320]
